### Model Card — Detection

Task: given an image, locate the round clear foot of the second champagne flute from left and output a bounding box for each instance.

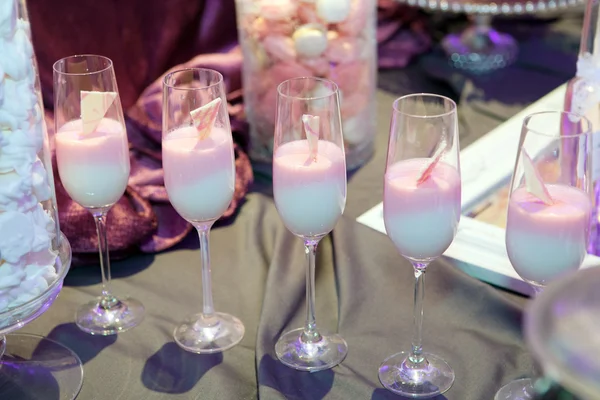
[173,313,245,354]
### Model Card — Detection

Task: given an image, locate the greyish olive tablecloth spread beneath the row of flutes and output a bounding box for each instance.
[21,11,581,400]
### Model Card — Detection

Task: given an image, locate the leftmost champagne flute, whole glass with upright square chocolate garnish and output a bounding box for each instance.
[54,55,144,335]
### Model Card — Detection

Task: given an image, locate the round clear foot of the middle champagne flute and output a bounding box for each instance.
[275,328,348,372]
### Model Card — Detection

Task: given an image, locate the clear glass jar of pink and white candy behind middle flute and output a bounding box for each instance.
[236,0,377,170]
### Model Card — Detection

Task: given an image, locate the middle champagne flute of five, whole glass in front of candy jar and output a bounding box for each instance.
[273,78,348,371]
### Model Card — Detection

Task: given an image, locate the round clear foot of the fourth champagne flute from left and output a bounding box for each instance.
[379,351,454,399]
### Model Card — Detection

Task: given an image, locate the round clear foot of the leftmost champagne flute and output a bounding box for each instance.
[75,297,145,336]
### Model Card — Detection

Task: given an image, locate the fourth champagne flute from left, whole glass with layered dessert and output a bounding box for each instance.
[379,94,461,398]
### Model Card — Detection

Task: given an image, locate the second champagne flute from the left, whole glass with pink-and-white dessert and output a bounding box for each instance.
[162,68,244,353]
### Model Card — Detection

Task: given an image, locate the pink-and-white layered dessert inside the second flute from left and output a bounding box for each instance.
[162,126,235,222]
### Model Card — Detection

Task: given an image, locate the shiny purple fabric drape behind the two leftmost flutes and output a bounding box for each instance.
[27,0,430,258]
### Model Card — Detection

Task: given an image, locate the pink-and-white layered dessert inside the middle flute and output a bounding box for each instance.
[273,140,346,237]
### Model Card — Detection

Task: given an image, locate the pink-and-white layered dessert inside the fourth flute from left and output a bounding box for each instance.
[383,158,461,261]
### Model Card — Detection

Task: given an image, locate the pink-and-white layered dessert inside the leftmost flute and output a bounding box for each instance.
[55,118,130,208]
